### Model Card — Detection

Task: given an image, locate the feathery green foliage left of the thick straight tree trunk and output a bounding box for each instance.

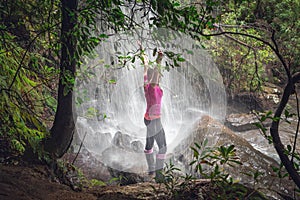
[0,1,57,152]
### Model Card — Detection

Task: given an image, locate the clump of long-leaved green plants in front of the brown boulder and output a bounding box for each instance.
[154,140,267,200]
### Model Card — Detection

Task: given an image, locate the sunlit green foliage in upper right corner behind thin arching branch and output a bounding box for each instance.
[206,0,300,95]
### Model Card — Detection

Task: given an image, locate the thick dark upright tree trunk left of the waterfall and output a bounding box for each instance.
[44,0,78,158]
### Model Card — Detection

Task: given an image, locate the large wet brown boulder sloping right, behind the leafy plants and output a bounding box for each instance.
[174,116,293,199]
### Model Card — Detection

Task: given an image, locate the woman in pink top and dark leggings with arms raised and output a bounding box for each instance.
[141,48,167,182]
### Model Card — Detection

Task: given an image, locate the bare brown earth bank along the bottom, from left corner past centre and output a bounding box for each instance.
[0,165,203,200]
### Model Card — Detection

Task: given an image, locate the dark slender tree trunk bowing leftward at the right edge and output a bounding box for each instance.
[270,73,300,188]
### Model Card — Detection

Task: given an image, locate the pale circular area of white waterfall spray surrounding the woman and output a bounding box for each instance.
[75,29,226,172]
